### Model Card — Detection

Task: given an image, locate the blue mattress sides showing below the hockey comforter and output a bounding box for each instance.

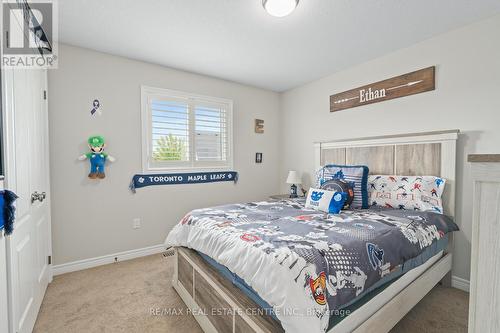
[198,235,448,329]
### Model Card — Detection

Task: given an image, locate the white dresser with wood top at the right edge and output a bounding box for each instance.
[468,154,500,333]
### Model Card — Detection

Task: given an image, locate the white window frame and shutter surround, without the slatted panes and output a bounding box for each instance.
[141,85,233,173]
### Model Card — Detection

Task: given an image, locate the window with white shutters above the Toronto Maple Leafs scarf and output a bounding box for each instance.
[141,86,233,172]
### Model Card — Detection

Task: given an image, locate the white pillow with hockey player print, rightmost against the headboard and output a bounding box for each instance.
[368,175,446,214]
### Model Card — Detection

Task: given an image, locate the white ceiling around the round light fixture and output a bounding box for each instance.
[58,0,500,91]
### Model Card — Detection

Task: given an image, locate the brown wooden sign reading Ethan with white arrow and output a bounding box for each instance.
[330,66,435,112]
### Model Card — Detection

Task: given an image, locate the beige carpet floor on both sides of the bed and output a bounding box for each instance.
[34,255,468,333]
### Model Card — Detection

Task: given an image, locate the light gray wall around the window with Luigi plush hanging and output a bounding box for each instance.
[49,45,280,265]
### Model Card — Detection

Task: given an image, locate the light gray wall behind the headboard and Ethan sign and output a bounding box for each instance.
[281,16,500,279]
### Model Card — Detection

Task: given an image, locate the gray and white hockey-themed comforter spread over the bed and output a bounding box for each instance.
[166,200,458,332]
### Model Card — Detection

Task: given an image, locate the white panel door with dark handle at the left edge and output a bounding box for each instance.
[4,69,52,333]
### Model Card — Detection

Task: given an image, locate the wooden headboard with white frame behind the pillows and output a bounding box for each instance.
[314,130,459,216]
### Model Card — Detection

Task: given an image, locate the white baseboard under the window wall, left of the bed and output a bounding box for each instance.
[52,244,165,275]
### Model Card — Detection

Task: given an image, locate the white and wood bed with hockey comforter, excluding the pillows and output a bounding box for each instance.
[167,131,458,333]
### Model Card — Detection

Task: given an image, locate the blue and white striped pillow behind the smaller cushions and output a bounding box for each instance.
[315,164,369,209]
